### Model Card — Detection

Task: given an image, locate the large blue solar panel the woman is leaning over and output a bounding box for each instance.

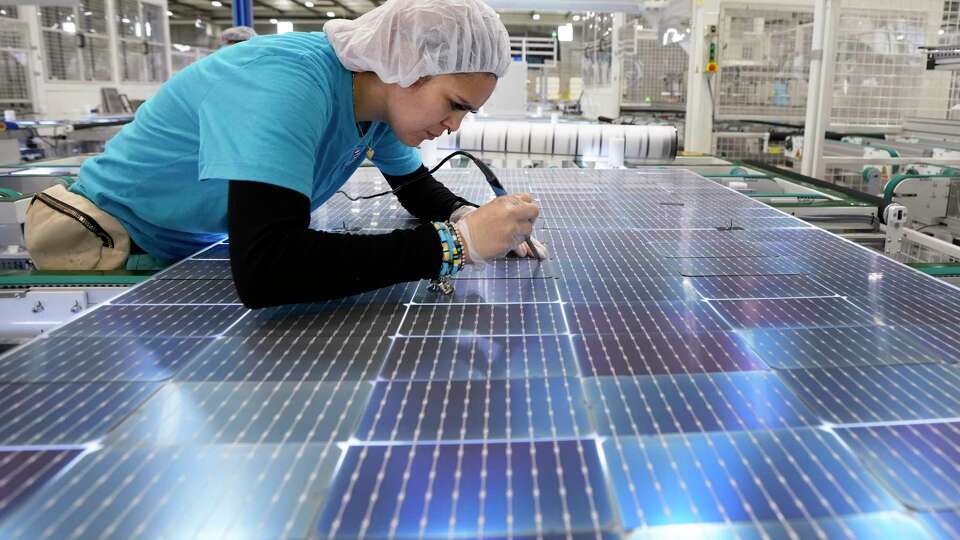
[0,168,960,539]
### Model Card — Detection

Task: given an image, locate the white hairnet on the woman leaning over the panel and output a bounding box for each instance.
[323,0,510,87]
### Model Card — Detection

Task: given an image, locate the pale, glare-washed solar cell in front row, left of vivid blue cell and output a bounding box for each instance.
[0,444,341,539]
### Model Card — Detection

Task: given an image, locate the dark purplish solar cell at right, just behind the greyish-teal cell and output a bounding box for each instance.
[710,297,875,330]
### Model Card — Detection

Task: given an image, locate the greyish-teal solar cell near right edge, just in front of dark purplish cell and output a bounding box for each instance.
[740,326,946,369]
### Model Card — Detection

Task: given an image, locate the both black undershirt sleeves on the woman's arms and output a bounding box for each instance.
[227,167,470,308]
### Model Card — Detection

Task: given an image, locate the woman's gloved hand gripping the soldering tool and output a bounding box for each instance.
[454,193,540,268]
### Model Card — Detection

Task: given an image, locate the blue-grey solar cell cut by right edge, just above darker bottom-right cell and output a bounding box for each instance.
[778,364,960,424]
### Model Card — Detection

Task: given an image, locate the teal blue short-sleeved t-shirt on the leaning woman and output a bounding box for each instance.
[70,32,421,260]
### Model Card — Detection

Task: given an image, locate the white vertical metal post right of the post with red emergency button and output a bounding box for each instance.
[800,0,840,178]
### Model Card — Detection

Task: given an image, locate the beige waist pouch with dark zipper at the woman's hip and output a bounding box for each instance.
[24,186,130,270]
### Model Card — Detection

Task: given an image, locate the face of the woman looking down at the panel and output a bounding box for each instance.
[387,73,497,146]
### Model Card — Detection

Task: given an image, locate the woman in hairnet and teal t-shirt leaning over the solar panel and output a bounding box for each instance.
[25,0,545,308]
